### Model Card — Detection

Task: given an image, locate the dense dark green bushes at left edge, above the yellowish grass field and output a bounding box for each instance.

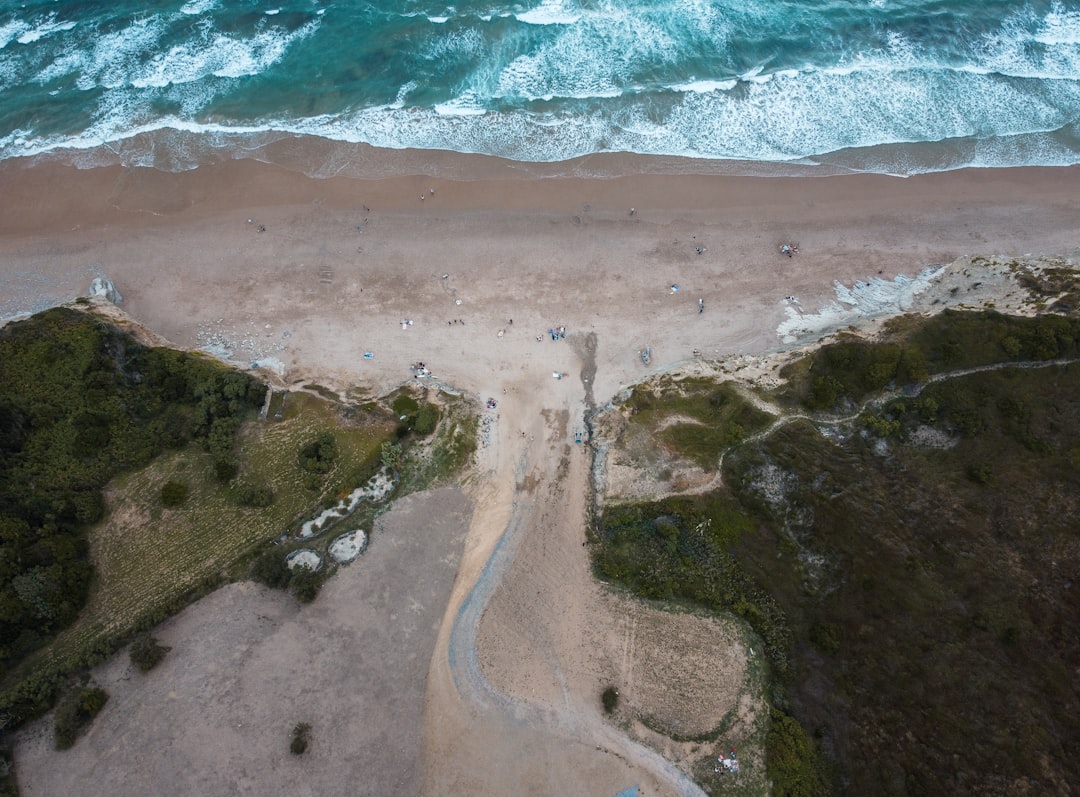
[0,308,265,670]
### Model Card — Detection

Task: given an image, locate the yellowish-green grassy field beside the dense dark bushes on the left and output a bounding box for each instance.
[35,394,393,663]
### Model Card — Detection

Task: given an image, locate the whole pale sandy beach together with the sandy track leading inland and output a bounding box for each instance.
[8,152,1080,795]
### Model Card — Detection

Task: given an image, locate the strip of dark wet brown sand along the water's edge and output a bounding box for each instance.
[0,145,1080,237]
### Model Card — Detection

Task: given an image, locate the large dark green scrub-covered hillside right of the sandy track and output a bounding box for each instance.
[594,313,1080,795]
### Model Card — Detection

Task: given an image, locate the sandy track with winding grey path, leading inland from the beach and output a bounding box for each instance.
[423,336,702,795]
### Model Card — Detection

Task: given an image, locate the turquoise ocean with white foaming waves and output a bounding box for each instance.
[0,0,1080,175]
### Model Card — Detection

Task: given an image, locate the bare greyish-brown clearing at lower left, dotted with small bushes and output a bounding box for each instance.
[16,488,472,797]
